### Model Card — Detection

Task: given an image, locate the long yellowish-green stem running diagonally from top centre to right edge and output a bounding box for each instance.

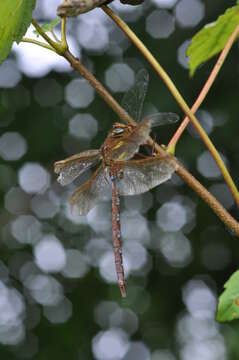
[102,5,239,207]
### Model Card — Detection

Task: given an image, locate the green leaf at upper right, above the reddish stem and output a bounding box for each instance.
[187,5,239,76]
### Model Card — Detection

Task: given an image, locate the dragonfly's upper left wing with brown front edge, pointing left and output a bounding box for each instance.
[54,150,101,186]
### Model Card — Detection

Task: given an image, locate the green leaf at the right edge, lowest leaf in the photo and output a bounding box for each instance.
[217,270,239,322]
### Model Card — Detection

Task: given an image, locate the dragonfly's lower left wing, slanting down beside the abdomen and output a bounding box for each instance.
[70,165,111,215]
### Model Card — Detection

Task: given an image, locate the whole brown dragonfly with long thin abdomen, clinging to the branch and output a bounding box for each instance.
[54,69,178,297]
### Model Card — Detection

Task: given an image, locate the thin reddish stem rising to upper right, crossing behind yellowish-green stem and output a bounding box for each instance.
[168,24,239,149]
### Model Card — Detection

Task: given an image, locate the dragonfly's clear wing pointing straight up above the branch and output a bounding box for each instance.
[121,69,149,121]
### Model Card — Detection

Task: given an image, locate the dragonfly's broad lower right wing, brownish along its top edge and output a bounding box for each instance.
[116,155,177,195]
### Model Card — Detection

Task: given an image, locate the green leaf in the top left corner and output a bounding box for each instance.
[0,0,36,63]
